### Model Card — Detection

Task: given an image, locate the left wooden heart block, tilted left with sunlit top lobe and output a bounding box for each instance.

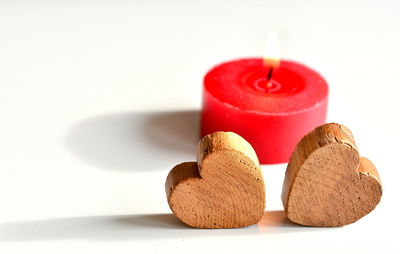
[165,132,265,228]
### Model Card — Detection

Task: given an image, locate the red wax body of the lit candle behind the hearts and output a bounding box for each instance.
[201,58,328,164]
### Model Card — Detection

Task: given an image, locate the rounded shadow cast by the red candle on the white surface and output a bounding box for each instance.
[66,110,199,172]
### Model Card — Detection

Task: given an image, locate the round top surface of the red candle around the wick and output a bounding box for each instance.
[204,58,328,114]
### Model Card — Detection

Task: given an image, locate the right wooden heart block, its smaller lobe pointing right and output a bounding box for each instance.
[282,123,382,227]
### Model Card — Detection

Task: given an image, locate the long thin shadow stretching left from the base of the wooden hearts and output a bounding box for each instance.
[0,211,324,242]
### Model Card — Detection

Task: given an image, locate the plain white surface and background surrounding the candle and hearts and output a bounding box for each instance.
[0,0,400,253]
